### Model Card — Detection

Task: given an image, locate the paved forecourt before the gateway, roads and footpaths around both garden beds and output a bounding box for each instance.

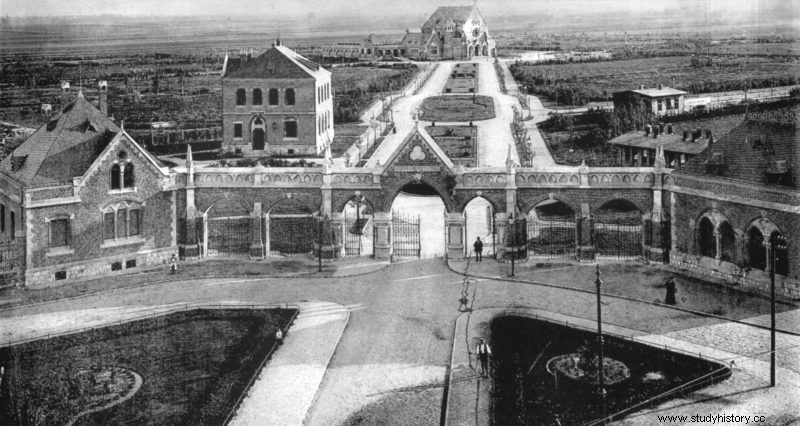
[0,258,800,425]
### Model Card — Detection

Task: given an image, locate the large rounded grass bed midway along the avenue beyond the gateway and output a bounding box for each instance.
[420,95,494,122]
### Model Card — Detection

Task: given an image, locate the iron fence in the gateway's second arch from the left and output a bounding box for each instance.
[269,214,318,256]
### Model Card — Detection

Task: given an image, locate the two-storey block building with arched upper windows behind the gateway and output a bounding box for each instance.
[222,40,333,156]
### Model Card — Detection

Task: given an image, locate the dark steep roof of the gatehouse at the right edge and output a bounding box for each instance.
[676,120,800,187]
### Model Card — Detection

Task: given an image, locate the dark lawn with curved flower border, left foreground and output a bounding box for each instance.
[0,309,296,425]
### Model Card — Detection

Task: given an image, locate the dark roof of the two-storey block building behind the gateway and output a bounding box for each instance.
[223,45,330,78]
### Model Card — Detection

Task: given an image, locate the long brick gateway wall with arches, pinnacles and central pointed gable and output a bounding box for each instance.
[176,148,670,262]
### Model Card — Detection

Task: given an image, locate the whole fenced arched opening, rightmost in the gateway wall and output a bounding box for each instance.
[593,199,642,258]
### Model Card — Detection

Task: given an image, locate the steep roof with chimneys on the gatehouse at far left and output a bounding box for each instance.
[0,93,120,186]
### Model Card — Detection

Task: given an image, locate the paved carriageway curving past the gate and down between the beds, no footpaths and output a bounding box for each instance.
[0,259,791,425]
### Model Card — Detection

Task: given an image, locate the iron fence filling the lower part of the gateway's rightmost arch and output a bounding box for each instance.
[592,220,643,259]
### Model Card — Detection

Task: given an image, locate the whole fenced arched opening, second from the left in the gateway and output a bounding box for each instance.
[270,198,317,256]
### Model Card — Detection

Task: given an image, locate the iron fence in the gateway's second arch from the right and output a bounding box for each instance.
[528,217,576,259]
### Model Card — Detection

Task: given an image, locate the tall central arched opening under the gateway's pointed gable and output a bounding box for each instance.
[391,182,446,258]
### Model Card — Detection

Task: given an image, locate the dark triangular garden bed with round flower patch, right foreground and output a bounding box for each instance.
[491,316,731,425]
